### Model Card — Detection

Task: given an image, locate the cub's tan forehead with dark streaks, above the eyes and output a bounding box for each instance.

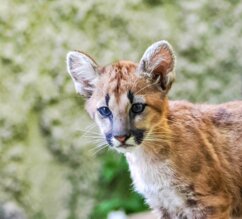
[93,61,159,105]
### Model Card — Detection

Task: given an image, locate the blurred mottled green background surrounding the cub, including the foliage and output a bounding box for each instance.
[0,0,242,219]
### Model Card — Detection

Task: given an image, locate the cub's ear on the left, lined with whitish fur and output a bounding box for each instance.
[66,51,98,98]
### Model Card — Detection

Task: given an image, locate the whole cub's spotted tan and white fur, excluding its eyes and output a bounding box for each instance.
[67,41,242,219]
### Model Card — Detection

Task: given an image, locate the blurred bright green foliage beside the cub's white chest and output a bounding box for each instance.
[91,152,147,219]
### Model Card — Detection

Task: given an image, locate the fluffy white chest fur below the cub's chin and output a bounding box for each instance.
[126,150,185,212]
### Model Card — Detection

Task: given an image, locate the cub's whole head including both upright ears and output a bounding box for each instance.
[67,41,175,152]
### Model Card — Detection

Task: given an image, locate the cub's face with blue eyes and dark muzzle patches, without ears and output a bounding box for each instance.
[86,61,163,151]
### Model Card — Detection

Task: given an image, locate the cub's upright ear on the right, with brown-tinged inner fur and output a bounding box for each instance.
[138,40,175,92]
